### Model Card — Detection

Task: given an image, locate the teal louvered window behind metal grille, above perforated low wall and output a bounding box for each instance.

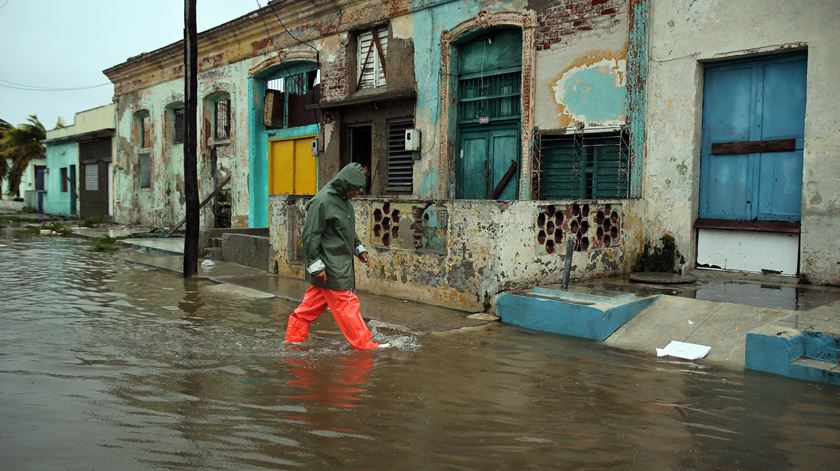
[539,129,630,200]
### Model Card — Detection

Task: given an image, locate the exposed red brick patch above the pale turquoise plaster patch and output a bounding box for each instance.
[536,0,627,50]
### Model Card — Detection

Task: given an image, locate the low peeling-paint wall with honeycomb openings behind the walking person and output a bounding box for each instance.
[270,196,638,311]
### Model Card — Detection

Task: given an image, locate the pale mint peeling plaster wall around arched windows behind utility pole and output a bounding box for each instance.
[114,61,249,227]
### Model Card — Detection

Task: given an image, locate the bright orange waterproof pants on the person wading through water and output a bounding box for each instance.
[286,285,379,350]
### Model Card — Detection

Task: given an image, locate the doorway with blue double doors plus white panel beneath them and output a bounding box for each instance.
[697,53,806,275]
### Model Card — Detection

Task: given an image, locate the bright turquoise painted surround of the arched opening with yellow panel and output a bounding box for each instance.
[248,63,320,227]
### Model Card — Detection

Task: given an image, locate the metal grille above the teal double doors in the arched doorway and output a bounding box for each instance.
[458,72,521,124]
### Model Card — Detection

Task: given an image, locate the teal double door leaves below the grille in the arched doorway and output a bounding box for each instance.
[458,126,520,200]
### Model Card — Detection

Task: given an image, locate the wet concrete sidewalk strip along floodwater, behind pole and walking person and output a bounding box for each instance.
[125,251,495,335]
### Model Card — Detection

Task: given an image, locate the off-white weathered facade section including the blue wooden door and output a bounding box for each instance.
[643,0,840,285]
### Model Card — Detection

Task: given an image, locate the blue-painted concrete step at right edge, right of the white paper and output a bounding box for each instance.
[744,324,840,386]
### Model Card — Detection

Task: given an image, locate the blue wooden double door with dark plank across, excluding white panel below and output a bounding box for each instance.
[700,54,806,221]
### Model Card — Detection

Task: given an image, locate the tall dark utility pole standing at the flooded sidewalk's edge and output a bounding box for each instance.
[184,0,199,278]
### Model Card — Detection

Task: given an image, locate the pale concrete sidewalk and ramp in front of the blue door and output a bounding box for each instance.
[592,272,840,369]
